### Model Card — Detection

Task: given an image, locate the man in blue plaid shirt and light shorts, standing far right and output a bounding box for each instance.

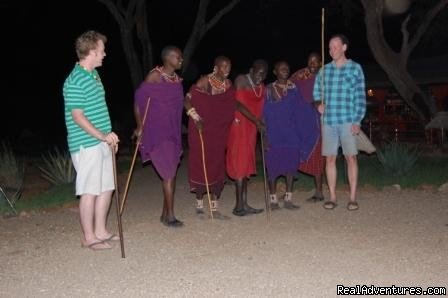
[313,34,366,210]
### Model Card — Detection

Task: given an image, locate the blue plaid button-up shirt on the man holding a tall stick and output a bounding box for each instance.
[313,59,366,125]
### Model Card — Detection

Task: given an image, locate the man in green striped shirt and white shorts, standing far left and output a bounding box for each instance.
[63,31,119,250]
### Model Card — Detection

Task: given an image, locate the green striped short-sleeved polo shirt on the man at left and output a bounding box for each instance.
[63,63,112,153]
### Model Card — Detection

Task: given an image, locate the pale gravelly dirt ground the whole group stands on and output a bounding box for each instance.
[0,162,448,297]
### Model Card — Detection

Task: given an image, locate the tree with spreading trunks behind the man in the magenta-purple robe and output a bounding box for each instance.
[98,0,241,89]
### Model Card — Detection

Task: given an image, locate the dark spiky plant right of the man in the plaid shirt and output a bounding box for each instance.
[377,142,420,177]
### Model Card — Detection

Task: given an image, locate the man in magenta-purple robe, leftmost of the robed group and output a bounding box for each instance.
[134,46,183,227]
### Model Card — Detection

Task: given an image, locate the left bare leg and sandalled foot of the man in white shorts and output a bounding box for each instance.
[79,194,111,249]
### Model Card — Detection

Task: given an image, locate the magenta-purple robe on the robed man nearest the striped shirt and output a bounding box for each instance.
[135,81,183,180]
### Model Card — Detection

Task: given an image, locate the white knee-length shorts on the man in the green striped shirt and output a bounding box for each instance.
[72,142,115,196]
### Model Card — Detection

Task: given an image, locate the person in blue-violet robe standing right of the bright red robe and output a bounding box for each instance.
[263,61,318,210]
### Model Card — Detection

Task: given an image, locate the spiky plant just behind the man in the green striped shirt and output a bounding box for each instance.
[38,147,75,185]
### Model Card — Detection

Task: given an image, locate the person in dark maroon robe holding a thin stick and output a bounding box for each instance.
[185,56,263,219]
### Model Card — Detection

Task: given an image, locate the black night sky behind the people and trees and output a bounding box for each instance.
[0,0,444,149]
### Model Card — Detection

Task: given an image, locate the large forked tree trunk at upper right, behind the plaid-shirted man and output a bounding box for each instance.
[330,0,448,121]
